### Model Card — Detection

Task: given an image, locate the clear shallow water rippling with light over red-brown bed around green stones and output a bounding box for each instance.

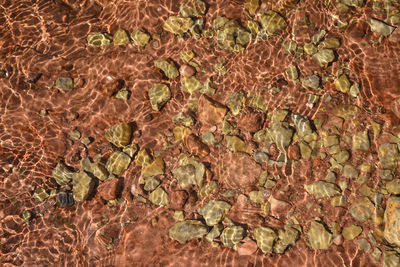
[0,0,400,266]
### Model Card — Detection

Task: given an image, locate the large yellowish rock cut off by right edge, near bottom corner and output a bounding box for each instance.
[384,196,400,246]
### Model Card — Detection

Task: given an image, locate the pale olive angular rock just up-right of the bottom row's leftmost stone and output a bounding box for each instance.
[197,200,231,226]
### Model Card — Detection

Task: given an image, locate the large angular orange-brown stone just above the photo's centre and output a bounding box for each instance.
[197,95,228,126]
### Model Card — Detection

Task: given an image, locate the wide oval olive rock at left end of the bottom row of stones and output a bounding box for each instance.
[169,220,208,243]
